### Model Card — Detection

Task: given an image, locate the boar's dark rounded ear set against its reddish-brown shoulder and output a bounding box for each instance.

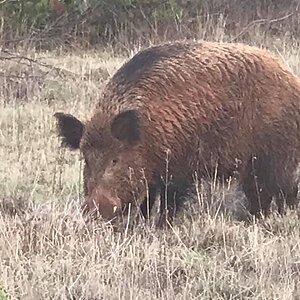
[111,110,140,144]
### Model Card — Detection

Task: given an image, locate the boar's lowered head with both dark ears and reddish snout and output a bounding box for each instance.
[55,110,146,219]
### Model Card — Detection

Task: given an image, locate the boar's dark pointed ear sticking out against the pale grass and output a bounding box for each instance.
[54,112,84,149]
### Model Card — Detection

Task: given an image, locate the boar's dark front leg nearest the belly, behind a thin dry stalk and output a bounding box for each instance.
[159,179,188,226]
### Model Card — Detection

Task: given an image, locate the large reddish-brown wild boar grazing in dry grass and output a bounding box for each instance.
[55,41,300,221]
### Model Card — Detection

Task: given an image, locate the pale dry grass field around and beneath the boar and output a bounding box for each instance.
[0,41,300,300]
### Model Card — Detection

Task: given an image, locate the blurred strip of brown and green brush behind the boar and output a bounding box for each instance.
[0,0,300,49]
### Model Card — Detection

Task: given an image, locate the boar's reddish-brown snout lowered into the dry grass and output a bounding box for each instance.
[82,188,122,220]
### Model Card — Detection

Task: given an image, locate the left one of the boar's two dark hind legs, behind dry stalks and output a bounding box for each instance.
[241,155,277,217]
